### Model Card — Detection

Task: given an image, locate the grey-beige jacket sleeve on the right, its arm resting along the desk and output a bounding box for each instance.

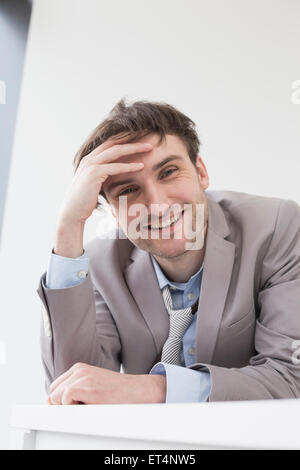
[189,200,300,401]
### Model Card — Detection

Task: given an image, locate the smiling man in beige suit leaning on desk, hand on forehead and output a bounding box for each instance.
[38,100,300,404]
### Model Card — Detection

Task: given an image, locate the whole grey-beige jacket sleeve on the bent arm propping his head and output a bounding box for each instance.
[37,272,121,393]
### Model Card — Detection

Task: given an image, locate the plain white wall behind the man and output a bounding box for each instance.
[0,0,300,447]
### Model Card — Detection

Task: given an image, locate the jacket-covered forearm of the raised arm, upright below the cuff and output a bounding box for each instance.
[38,275,101,390]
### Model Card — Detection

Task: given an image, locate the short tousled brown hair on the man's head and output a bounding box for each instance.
[73,98,200,202]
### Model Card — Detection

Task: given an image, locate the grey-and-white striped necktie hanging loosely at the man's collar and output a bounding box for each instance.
[161,286,193,366]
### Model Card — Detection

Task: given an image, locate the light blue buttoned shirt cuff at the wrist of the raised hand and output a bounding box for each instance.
[46,250,89,289]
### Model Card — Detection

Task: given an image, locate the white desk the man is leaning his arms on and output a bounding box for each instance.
[10,399,300,450]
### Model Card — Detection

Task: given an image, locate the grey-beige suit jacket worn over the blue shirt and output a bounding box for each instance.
[38,191,300,401]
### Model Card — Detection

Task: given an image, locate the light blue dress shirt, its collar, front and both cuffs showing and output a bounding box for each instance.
[46,251,211,403]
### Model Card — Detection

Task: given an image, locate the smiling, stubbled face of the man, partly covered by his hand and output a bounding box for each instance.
[102,134,208,258]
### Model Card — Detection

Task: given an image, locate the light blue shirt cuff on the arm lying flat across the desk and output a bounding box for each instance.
[149,362,212,403]
